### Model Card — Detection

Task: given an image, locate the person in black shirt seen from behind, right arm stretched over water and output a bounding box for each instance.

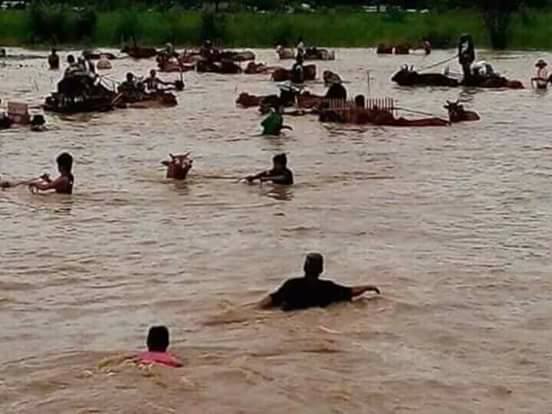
[259,253,381,311]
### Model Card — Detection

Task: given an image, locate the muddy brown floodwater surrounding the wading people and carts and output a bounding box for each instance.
[0,49,552,414]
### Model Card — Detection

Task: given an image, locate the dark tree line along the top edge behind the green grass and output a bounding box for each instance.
[23,0,552,49]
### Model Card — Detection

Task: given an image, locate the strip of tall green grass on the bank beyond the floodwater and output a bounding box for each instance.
[0,10,552,49]
